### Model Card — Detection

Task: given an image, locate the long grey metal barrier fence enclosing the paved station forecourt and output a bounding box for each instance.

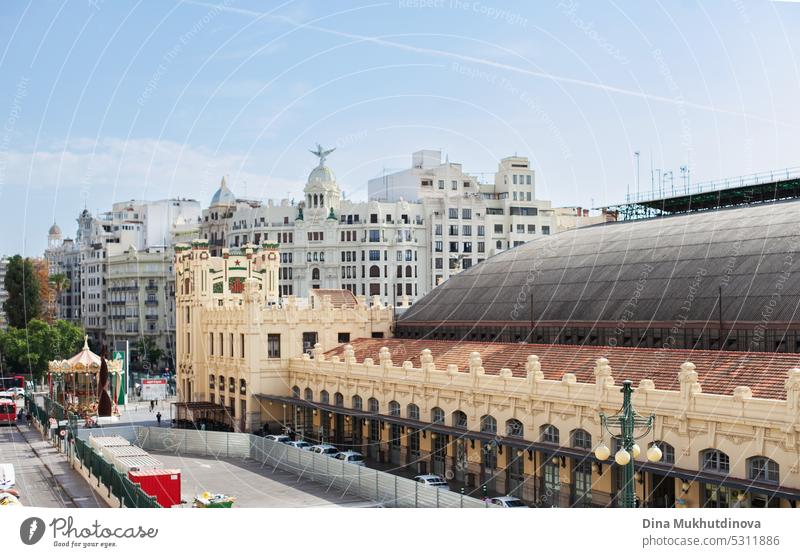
[136,427,494,508]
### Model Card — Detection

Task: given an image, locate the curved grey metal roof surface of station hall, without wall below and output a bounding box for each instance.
[399,201,800,328]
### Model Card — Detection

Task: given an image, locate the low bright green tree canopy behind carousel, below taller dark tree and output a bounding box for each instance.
[0,319,83,379]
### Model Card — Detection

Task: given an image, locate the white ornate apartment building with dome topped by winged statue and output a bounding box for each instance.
[200,152,430,306]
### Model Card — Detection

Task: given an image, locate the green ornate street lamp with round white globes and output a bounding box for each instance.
[595,379,661,508]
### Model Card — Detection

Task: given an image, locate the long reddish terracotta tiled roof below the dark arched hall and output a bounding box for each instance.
[326,338,800,400]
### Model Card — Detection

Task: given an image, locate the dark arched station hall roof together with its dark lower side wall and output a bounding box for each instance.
[397,200,800,352]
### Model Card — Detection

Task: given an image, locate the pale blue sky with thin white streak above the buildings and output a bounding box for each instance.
[0,0,800,255]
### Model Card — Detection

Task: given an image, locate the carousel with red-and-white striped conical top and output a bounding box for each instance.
[48,336,122,422]
